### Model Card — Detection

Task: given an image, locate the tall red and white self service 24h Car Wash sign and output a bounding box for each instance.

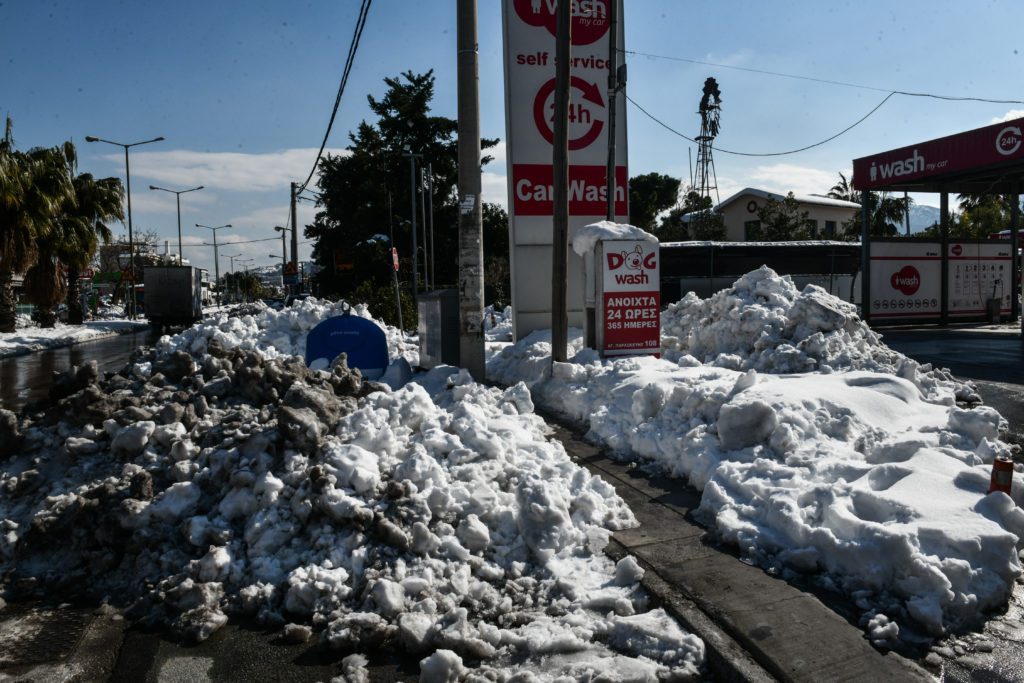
[502,0,629,338]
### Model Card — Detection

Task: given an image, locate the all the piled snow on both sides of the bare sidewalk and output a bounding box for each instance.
[0,268,1024,680]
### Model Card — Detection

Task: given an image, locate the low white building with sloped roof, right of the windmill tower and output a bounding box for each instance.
[715,187,860,242]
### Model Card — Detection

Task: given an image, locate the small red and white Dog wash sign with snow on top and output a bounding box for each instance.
[597,240,662,355]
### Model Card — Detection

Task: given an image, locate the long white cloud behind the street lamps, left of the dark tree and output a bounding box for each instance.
[106,148,349,192]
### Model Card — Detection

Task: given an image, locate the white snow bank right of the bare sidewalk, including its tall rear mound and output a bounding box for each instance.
[487,269,1024,642]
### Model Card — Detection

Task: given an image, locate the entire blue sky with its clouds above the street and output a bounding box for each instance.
[0,0,1024,269]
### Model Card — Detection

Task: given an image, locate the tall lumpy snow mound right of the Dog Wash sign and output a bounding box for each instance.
[662,266,980,401]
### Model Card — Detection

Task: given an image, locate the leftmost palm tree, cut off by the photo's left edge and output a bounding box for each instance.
[0,118,73,332]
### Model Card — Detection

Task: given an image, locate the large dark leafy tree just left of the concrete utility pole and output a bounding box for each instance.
[305,71,499,327]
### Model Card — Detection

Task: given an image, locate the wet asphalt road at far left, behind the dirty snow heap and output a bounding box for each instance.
[0,330,160,412]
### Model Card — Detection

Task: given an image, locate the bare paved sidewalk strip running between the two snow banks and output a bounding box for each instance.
[546,416,935,683]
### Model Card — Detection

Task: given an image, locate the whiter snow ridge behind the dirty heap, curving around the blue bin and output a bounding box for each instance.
[157,297,419,366]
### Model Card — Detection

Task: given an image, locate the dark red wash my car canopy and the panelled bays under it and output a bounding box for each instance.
[853,119,1024,324]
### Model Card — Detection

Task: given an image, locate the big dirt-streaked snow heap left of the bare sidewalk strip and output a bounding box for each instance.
[0,304,703,680]
